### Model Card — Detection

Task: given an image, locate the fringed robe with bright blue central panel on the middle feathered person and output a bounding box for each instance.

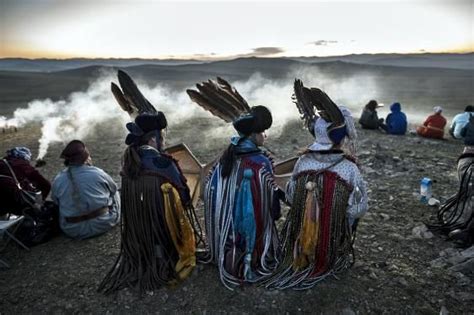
[204,147,280,289]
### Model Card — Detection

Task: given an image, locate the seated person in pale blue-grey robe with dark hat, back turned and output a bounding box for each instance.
[51,140,120,239]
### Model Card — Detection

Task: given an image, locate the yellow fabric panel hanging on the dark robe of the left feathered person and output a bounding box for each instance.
[161,183,196,279]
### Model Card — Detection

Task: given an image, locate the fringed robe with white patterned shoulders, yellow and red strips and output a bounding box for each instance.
[265,152,367,289]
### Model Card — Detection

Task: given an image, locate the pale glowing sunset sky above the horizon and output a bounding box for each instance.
[0,0,474,59]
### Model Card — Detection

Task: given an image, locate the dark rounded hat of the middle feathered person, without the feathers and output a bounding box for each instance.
[232,105,273,136]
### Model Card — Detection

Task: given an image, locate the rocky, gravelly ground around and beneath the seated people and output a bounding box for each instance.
[0,119,474,314]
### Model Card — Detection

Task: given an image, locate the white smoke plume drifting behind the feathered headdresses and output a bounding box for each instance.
[0,67,414,158]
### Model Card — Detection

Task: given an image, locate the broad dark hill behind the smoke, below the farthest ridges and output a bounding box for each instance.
[0,55,474,115]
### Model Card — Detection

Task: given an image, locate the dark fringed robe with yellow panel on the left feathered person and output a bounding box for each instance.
[99,146,196,293]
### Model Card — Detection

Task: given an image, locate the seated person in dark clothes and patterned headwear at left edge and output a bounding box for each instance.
[0,147,51,216]
